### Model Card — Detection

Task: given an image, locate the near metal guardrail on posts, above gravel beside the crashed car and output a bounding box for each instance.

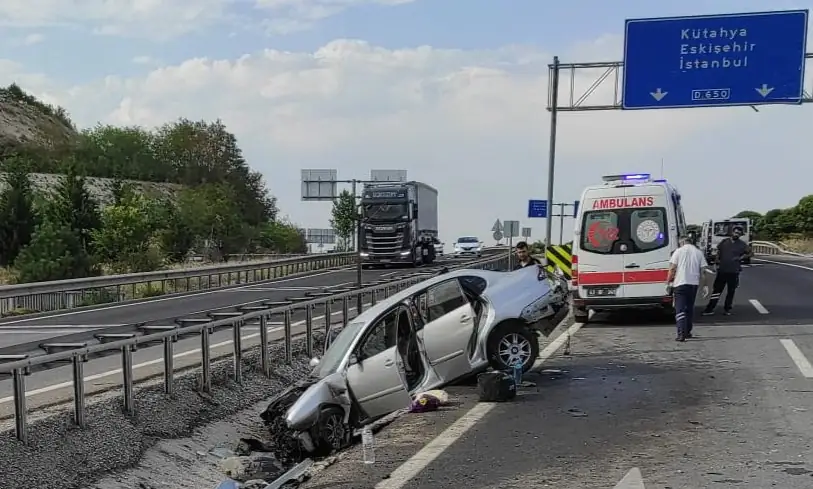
[0,254,508,443]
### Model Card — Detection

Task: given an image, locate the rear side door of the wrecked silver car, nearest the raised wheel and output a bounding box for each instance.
[417,278,475,381]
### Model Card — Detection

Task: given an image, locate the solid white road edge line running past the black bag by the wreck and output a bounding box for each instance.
[375,323,583,489]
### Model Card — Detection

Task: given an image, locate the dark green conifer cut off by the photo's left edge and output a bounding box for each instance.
[0,158,37,267]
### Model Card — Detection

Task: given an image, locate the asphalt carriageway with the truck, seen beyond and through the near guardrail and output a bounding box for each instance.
[0,254,482,417]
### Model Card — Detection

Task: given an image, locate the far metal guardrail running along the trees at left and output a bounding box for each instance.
[0,253,356,317]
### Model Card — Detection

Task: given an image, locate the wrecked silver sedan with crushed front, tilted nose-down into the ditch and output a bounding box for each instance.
[262,267,568,454]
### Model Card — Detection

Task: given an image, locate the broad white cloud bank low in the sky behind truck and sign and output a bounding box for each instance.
[0,39,813,241]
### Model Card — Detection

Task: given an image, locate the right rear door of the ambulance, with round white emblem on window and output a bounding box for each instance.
[619,185,679,299]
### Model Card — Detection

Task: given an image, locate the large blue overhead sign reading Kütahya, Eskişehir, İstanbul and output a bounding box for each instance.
[622,10,808,109]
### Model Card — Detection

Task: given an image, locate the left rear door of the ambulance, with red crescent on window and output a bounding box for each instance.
[577,191,625,301]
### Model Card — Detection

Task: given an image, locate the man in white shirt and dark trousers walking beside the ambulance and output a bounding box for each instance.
[666,234,708,342]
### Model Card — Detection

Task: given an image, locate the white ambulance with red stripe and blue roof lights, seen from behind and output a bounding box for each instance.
[571,173,708,323]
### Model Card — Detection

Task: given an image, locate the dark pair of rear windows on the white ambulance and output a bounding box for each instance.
[581,207,669,255]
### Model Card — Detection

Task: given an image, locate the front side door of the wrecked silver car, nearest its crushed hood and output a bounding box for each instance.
[347,305,412,418]
